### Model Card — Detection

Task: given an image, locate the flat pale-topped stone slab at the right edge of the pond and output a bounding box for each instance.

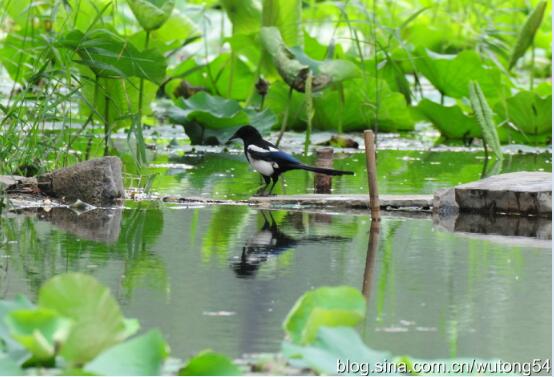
[454,172,552,216]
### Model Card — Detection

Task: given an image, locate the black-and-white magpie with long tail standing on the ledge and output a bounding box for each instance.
[227,125,354,195]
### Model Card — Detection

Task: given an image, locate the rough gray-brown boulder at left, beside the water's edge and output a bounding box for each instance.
[38,157,125,206]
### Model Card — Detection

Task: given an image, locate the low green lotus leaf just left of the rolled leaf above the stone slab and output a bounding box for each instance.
[415,99,481,139]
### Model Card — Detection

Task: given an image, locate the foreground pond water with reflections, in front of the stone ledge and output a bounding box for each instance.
[0,204,552,361]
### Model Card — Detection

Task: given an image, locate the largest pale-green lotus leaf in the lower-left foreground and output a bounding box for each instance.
[38,273,138,365]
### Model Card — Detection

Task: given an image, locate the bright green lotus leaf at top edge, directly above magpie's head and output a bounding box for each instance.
[220,0,262,35]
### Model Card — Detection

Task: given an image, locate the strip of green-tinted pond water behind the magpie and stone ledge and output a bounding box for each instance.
[137,150,552,199]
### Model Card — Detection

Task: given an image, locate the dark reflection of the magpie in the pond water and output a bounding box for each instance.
[231,211,350,278]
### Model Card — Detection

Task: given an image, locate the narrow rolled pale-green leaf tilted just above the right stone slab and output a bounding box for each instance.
[469,81,503,160]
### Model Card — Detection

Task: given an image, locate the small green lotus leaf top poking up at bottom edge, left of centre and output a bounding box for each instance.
[178,350,242,376]
